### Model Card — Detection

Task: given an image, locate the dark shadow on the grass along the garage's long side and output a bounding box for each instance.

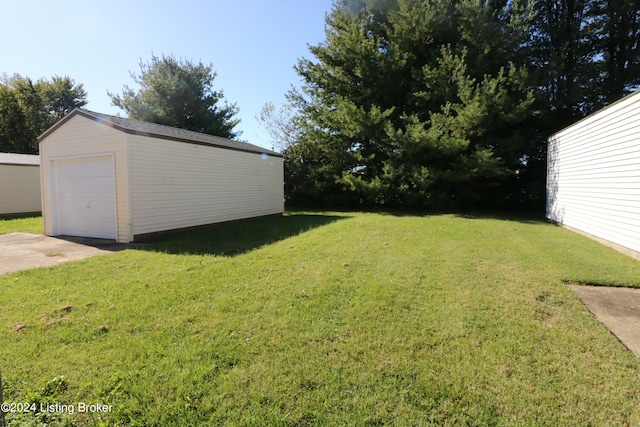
[139,213,349,256]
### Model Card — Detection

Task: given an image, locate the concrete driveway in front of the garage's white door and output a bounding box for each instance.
[0,233,132,274]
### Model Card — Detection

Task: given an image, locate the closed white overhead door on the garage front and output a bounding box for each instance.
[52,157,117,239]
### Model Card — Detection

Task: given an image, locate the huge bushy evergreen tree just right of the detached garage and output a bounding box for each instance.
[288,0,533,207]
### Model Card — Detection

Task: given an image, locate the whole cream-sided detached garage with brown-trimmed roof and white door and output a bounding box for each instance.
[38,109,284,242]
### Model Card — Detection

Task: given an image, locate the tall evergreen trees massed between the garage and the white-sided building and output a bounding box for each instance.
[284,0,640,209]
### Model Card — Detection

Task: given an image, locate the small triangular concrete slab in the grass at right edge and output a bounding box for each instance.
[569,285,640,357]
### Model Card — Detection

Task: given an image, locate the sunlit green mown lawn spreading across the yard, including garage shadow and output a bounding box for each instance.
[0,212,640,426]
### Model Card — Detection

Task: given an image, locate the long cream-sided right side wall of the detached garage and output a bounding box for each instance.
[129,135,284,235]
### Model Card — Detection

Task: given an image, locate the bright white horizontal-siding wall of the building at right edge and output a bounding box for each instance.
[546,91,640,257]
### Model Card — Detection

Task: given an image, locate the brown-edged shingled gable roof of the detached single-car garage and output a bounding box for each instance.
[38,108,282,157]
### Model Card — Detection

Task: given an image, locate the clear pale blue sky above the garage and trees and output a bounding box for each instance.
[0,0,332,148]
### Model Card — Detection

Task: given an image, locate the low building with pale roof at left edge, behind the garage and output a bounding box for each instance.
[0,153,42,215]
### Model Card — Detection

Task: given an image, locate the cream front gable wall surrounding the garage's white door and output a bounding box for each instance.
[40,115,133,242]
